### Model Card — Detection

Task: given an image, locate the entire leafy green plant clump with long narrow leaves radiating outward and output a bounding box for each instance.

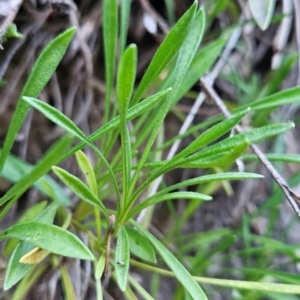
[0,0,300,299]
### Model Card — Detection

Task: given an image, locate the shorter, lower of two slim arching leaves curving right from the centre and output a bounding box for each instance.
[128,192,212,219]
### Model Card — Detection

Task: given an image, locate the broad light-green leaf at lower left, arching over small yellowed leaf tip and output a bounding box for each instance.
[0,222,94,260]
